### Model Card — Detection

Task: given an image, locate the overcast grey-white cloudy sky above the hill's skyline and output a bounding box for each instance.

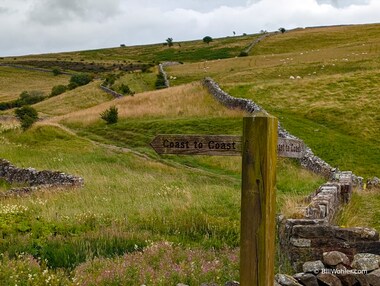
[0,0,380,56]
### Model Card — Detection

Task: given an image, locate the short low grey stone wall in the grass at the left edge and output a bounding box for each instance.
[0,159,84,194]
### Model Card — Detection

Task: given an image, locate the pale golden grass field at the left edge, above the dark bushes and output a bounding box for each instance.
[0,66,69,102]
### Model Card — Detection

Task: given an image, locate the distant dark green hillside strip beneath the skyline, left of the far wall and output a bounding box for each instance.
[5,35,258,64]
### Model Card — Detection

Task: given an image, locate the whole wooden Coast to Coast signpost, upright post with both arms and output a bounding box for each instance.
[151,115,305,286]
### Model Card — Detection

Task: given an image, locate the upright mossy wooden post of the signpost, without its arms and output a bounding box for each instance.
[240,115,278,286]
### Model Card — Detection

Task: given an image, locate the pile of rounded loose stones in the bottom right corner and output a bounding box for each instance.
[275,251,380,286]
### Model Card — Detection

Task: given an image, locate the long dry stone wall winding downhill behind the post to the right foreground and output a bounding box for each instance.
[203,78,380,278]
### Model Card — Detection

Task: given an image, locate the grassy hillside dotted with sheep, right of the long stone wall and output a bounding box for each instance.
[168,25,380,177]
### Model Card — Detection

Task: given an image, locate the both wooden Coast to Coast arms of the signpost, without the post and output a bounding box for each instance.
[150,134,305,158]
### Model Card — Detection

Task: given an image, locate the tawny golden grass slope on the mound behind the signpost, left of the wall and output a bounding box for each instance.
[52,83,243,125]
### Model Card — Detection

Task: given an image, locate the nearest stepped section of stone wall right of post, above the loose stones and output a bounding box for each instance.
[278,172,380,271]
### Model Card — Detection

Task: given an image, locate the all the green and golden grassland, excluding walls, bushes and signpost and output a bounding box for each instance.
[0,22,380,285]
